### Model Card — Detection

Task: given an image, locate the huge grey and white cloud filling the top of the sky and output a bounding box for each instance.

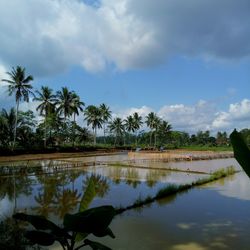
[0,0,250,76]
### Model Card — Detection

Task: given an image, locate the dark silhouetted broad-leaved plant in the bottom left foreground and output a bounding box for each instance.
[13,206,116,250]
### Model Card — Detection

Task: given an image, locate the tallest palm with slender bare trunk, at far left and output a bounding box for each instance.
[2,66,33,148]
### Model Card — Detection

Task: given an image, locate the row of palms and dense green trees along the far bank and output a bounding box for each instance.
[0,66,240,153]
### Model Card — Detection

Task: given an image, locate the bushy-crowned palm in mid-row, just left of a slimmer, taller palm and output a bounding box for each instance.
[84,105,103,145]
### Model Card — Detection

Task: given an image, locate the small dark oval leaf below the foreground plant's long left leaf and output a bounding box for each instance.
[25,231,56,246]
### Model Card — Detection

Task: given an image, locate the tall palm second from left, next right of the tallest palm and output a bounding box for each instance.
[33,86,56,148]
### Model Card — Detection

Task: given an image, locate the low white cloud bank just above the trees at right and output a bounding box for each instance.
[114,99,250,134]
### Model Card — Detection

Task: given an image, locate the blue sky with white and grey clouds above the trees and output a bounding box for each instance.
[0,0,250,133]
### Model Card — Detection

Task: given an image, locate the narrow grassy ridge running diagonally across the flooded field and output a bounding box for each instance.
[116,166,237,214]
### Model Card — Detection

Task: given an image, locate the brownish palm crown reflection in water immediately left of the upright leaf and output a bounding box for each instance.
[54,189,81,218]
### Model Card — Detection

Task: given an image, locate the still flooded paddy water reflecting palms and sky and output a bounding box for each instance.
[0,155,250,250]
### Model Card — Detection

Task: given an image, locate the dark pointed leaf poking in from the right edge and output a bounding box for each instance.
[230,130,250,177]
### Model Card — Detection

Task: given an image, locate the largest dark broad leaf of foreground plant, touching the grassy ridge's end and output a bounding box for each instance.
[63,206,115,233]
